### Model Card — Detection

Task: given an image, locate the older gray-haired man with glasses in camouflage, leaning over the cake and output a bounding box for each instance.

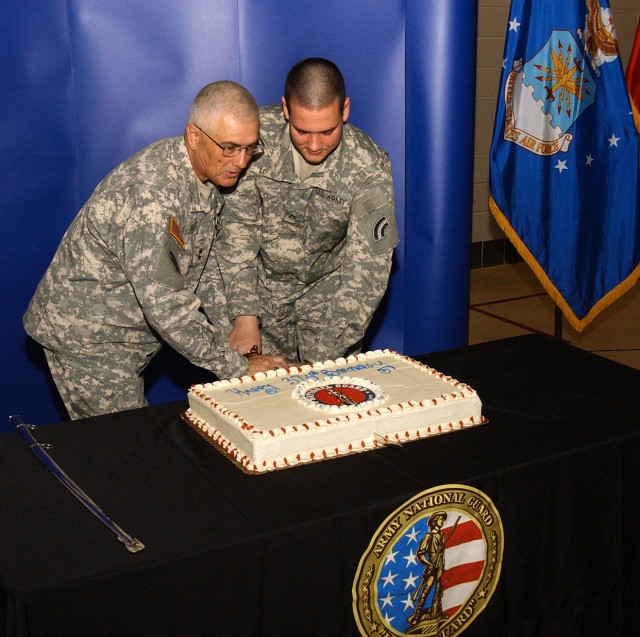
[24,81,285,418]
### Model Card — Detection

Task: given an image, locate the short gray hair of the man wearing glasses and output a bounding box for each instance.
[187,80,259,125]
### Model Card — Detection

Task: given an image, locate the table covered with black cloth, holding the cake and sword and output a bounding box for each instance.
[0,336,640,637]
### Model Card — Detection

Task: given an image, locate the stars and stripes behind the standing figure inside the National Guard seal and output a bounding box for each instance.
[376,510,487,632]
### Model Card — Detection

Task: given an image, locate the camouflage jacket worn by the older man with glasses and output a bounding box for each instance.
[24,137,247,377]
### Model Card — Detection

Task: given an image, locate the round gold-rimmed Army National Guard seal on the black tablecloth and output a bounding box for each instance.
[353,484,504,637]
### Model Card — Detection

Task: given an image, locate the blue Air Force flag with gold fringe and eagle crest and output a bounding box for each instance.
[489,0,640,331]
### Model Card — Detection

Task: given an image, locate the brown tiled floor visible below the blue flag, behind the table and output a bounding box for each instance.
[469,262,640,369]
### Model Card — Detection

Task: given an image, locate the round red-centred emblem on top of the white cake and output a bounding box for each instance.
[292,376,387,412]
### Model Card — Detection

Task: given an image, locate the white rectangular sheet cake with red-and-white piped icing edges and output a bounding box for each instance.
[185,350,484,473]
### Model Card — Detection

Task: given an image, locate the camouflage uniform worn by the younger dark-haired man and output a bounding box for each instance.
[216,106,398,361]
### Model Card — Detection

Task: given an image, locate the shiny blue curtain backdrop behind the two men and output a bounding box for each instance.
[0,0,477,431]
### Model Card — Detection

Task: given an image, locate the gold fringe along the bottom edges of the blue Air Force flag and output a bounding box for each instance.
[489,195,640,332]
